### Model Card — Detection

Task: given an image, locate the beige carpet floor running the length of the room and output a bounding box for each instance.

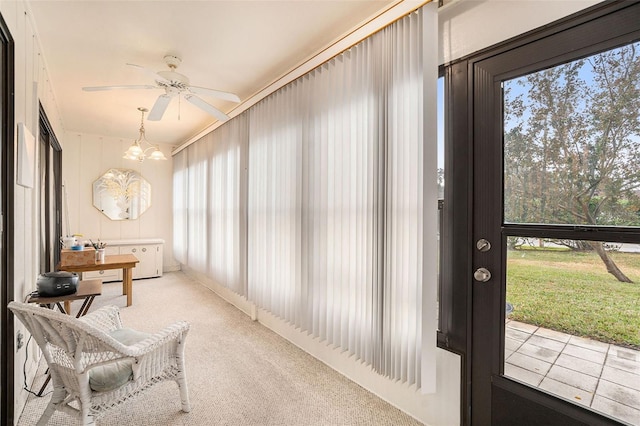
[18,272,422,426]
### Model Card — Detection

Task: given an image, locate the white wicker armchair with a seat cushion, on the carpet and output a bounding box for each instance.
[8,302,191,425]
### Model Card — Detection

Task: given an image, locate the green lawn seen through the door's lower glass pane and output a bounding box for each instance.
[507,250,640,349]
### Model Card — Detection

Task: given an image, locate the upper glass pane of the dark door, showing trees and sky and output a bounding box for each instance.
[503,42,640,227]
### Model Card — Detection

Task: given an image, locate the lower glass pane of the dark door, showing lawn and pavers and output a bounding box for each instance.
[504,237,640,425]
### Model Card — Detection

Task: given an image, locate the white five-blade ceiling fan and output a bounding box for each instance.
[82,55,240,121]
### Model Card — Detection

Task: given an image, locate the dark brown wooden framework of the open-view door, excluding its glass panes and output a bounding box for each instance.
[470,2,640,426]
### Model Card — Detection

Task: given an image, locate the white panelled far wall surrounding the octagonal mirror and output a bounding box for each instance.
[62,133,180,271]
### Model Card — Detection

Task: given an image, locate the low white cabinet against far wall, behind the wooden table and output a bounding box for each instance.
[82,238,164,282]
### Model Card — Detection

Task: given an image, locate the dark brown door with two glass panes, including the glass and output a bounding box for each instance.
[470,2,640,425]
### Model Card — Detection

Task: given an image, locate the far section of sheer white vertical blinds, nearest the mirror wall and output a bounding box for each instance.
[173,114,248,295]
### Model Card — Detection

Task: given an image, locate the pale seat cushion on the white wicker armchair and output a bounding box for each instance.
[89,328,151,392]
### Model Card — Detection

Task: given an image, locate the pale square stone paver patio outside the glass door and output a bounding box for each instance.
[504,320,640,426]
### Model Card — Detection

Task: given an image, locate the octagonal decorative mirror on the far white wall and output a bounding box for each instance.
[93,169,151,220]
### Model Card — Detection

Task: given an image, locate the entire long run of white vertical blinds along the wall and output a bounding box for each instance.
[174,4,437,389]
